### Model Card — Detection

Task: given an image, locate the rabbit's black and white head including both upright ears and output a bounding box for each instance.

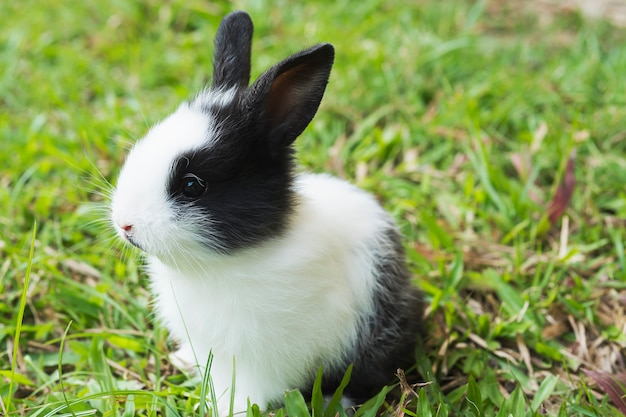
[112,12,334,265]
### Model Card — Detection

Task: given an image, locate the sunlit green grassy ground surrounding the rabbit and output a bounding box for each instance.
[0,0,626,416]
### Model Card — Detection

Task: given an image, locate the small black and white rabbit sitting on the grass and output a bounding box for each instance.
[111,8,422,414]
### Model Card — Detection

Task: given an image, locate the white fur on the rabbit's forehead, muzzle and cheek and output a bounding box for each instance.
[112,100,221,257]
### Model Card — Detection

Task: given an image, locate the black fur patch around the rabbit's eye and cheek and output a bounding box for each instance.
[167,91,295,253]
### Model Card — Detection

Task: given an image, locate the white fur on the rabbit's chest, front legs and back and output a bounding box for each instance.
[115,168,389,415]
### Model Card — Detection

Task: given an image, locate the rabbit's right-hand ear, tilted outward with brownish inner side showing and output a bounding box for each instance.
[251,43,335,151]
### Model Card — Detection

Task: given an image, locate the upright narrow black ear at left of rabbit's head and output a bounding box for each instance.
[212,11,254,90]
